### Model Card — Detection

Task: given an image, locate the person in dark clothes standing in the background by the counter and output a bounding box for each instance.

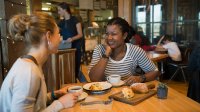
[58,2,84,82]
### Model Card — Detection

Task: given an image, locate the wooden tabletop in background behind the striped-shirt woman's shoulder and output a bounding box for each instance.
[146,51,168,62]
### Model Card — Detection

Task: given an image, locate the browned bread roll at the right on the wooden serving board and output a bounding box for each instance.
[130,83,149,93]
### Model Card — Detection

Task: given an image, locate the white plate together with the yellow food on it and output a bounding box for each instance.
[83,82,112,94]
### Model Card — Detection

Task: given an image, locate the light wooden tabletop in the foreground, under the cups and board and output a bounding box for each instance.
[61,81,200,112]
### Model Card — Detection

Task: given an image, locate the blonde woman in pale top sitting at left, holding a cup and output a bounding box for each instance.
[0,12,80,112]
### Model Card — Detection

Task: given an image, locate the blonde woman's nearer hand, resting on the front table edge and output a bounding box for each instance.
[58,93,81,108]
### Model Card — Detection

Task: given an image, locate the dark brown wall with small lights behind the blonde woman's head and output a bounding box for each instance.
[0,0,27,86]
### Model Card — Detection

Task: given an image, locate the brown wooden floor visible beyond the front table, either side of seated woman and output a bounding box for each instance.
[81,64,188,96]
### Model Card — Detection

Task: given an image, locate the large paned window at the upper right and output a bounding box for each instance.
[132,0,200,44]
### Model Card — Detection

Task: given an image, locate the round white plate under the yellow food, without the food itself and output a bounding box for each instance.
[83,82,112,92]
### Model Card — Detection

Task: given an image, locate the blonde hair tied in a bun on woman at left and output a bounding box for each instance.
[8,12,56,48]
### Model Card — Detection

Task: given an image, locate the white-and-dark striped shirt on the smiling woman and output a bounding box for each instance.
[89,43,157,80]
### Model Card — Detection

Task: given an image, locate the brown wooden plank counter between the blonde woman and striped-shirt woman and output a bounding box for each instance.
[43,49,76,91]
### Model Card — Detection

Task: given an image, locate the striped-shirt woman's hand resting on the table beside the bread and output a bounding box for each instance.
[124,76,142,85]
